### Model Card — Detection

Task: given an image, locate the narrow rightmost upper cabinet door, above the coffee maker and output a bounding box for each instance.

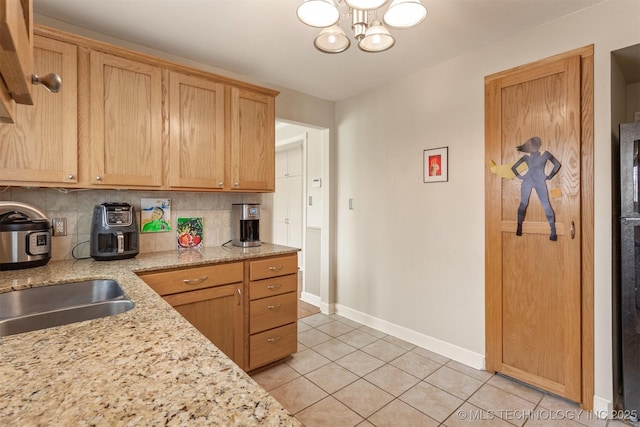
[230,88,275,192]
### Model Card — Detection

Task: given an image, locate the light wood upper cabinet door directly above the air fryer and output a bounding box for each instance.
[88,51,163,188]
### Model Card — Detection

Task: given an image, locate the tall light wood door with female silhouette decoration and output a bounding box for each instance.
[485,46,592,404]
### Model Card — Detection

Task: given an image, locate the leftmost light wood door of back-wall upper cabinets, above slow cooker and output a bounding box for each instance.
[0,36,78,185]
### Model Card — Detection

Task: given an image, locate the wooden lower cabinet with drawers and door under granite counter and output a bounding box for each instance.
[138,253,298,371]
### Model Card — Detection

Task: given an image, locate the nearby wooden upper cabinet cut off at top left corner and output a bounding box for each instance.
[0,0,33,123]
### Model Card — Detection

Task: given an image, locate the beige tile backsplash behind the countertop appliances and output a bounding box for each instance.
[0,187,264,260]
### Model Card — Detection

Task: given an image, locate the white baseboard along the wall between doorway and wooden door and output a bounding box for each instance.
[335,304,486,370]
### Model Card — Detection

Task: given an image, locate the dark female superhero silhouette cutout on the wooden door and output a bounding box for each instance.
[511,136,560,241]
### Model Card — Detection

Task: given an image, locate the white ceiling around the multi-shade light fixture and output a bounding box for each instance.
[33,0,603,101]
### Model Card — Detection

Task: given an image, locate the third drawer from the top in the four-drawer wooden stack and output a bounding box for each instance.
[249,292,298,334]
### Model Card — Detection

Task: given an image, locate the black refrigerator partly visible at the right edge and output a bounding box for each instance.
[614,118,640,418]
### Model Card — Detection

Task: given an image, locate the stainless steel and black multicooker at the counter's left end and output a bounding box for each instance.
[0,204,51,270]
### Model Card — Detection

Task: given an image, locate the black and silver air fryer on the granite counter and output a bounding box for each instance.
[89,203,139,261]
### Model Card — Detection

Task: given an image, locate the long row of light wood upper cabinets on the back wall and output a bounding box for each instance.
[0,25,278,192]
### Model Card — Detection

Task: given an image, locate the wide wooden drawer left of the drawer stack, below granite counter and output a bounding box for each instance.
[139,262,243,295]
